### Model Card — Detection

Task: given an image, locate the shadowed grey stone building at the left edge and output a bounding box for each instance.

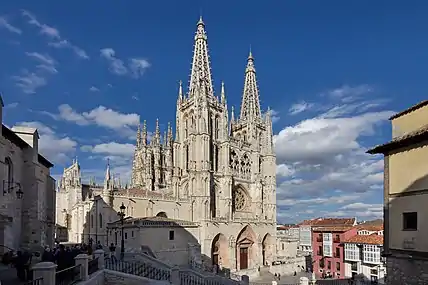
[0,96,55,253]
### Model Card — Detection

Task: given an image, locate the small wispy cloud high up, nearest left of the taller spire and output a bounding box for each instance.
[100,48,150,78]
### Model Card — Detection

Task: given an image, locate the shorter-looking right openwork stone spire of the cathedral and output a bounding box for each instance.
[239,51,262,121]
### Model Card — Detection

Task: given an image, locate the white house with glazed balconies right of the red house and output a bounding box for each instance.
[344,226,386,282]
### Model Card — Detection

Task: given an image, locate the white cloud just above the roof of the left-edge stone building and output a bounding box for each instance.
[16,122,77,164]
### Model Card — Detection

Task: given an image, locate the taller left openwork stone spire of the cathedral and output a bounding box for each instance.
[189,17,214,97]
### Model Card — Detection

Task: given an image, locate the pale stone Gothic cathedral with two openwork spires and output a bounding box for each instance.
[57,18,276,271]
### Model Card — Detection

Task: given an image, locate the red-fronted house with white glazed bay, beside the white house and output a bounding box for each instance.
[312,226,357,279]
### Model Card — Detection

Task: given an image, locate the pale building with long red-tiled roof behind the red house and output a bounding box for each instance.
[298,218,357,255]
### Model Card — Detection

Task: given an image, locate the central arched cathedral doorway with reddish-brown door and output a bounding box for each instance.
[236,226,257,270]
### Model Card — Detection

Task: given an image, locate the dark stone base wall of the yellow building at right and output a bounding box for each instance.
[386,257,428,285]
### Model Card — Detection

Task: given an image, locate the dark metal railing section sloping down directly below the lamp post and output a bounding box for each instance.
[105,259,171,281]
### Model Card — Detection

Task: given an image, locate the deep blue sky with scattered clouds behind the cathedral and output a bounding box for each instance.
[0,0,428,222]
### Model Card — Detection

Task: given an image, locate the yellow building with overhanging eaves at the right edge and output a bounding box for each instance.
[368,100,428,285]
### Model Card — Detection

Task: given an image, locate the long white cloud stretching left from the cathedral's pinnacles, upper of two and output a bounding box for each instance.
[42,104,140,137]
